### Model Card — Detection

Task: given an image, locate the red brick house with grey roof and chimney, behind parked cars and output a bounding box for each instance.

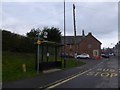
[61,31,102,57]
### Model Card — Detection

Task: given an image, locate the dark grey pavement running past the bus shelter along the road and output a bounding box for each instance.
[2,60,103,90]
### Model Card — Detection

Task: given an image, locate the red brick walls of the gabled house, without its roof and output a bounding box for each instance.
[63,33,101,57]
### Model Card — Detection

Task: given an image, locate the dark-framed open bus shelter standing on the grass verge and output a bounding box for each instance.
[36,41,63,71]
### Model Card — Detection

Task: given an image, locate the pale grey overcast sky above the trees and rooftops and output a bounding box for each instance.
[0,0,118,47]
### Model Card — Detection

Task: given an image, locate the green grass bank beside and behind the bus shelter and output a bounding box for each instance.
[2,52,85,82]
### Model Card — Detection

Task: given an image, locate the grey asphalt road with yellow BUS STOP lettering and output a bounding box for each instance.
[48,57,120,88]
